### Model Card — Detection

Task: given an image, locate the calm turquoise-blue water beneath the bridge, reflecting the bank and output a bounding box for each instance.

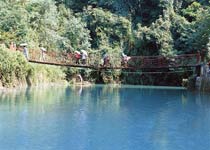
[0,85,210,150]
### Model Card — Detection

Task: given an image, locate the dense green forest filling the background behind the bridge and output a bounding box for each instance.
[0,0,210,84]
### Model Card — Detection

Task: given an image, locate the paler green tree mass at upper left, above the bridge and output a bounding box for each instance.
[0,0,90,51]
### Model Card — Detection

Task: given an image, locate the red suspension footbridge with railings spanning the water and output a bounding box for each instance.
[28,50,201,73]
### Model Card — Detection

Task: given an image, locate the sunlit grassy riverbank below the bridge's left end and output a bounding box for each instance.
[0,47,66,89]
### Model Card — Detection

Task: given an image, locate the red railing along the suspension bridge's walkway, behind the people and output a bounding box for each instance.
[27,50,200,68]
